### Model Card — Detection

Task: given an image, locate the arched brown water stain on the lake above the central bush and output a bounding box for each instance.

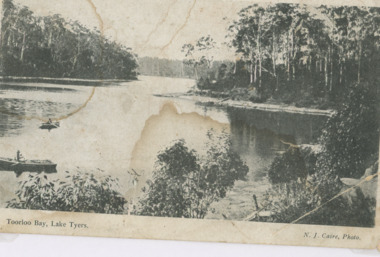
[126,102,229,202]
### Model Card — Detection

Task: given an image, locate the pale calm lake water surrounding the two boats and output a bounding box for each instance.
[0,77,325,219]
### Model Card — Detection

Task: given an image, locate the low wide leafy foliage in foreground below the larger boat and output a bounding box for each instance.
[7,172,126,214]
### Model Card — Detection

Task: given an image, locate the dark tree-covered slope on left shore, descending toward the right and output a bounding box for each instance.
[1,0,137,79]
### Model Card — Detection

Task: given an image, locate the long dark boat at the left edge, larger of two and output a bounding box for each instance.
[0,157,57,176]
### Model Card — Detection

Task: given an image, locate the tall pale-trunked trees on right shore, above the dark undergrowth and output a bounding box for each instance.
[229,4,380,91]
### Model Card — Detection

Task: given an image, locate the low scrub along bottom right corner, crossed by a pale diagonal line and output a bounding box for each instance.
[263,176,376,227]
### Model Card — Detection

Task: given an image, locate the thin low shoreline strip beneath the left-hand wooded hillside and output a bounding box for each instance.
[0,76,137,86]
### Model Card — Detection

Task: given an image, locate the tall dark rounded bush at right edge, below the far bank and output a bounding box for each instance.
[317,85,379,178]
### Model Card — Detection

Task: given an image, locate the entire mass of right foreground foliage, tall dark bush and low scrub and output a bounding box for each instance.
[263,86,379,226]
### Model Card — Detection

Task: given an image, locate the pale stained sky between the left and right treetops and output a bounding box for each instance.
[15,0,249,60]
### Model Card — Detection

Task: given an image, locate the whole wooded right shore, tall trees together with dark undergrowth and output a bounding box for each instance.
[184,3,380,108]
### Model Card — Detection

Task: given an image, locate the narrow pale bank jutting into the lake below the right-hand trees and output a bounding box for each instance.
[155,93,334,116]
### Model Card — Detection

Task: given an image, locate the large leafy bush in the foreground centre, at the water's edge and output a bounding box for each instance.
[137,133,248,219]
